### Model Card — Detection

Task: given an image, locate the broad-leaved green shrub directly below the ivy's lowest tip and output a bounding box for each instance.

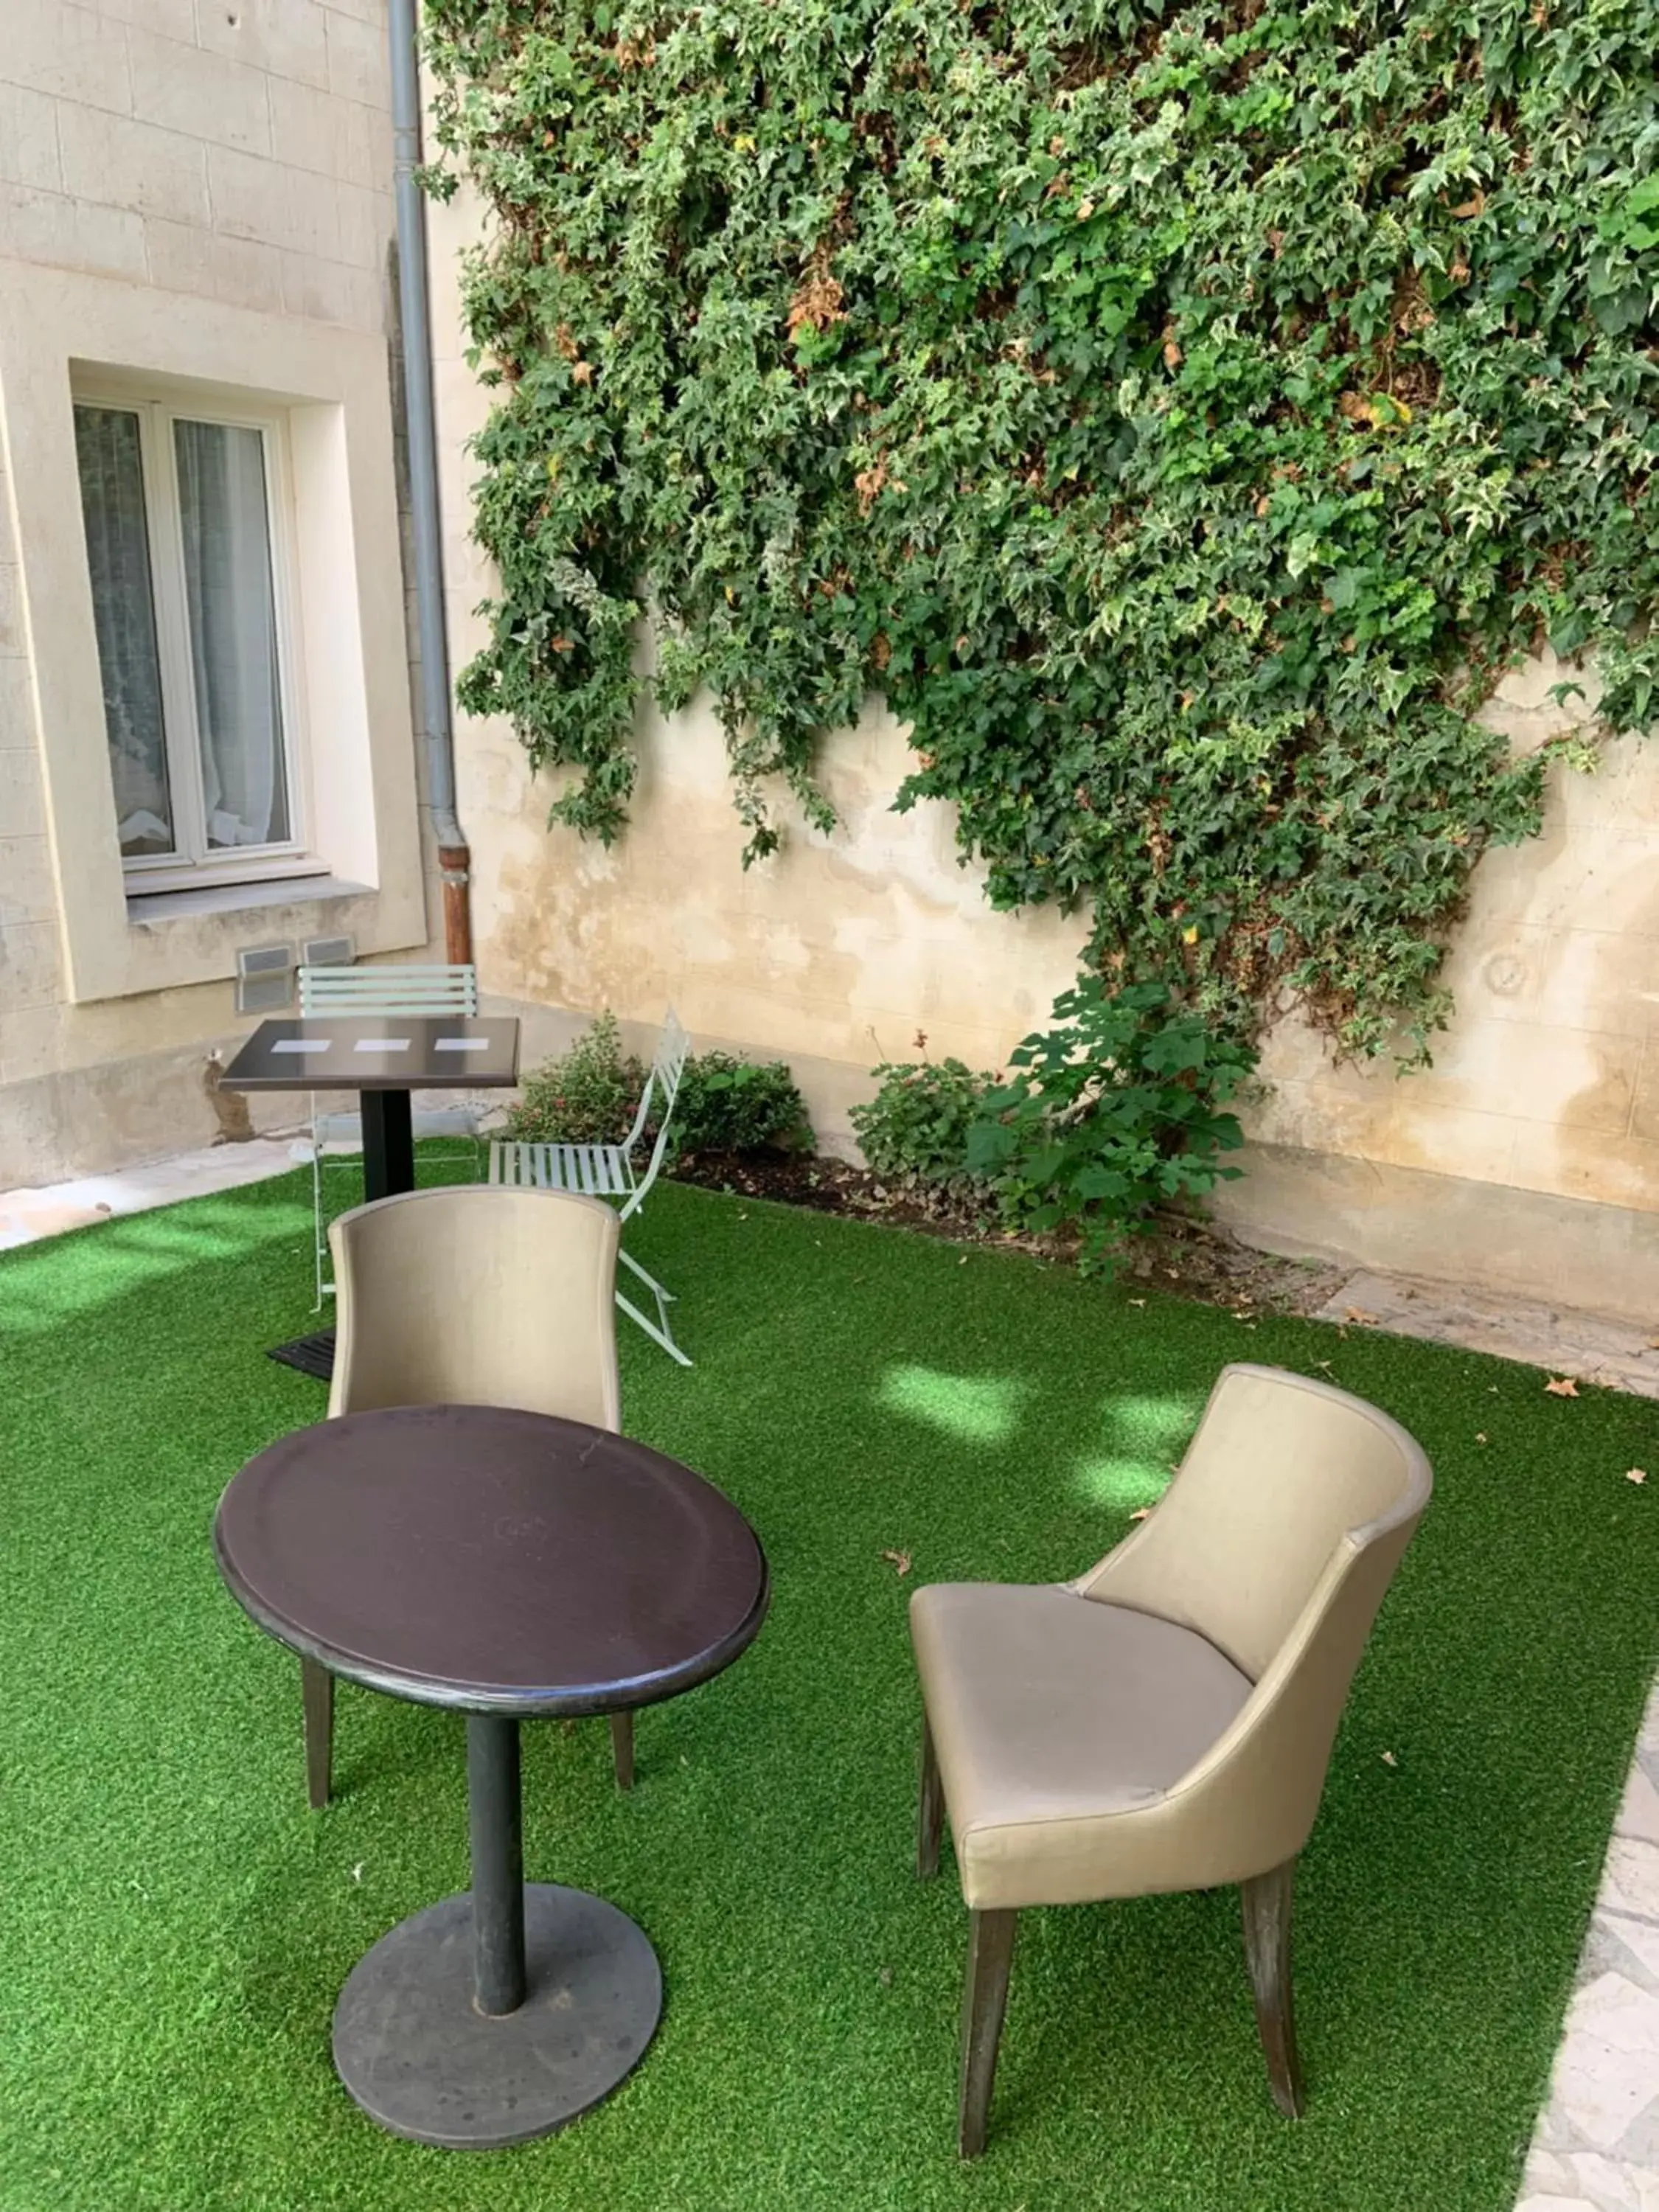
[967,975,1254,1270]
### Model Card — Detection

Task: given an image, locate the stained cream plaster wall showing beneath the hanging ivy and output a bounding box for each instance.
[434,177,1659,1314]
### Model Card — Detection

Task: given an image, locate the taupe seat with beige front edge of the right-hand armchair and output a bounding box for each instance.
[911,1582,1252,1909]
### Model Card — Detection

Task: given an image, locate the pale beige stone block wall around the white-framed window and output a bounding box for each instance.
[0,0,436,1188]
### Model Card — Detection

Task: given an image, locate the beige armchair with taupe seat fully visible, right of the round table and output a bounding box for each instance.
[911,1367,1429,2157]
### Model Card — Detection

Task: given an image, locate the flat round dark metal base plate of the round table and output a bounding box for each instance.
[334,1882,661,2150]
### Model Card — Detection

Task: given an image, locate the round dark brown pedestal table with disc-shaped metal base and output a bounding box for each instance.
[215,1405,768,2150]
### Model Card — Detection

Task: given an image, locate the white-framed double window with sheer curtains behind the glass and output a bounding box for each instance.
[73,380,323,896]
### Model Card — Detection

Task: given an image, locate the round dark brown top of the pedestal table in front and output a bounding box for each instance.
[215,1405,768,1714]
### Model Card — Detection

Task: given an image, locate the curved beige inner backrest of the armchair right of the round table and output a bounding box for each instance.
[1077,1365,1431,1681]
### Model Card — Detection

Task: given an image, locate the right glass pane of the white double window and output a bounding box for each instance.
[173,422,292,849]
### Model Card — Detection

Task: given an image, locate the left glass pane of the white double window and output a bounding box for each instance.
[75,407,173,856]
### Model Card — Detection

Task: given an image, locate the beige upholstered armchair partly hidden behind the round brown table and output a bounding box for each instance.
[301,1183,633,1805]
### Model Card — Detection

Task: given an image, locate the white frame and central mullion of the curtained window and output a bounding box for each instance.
[71,374,327,898]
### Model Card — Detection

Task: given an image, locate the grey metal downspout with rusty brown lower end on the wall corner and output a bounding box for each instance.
[389,0,473,967]
